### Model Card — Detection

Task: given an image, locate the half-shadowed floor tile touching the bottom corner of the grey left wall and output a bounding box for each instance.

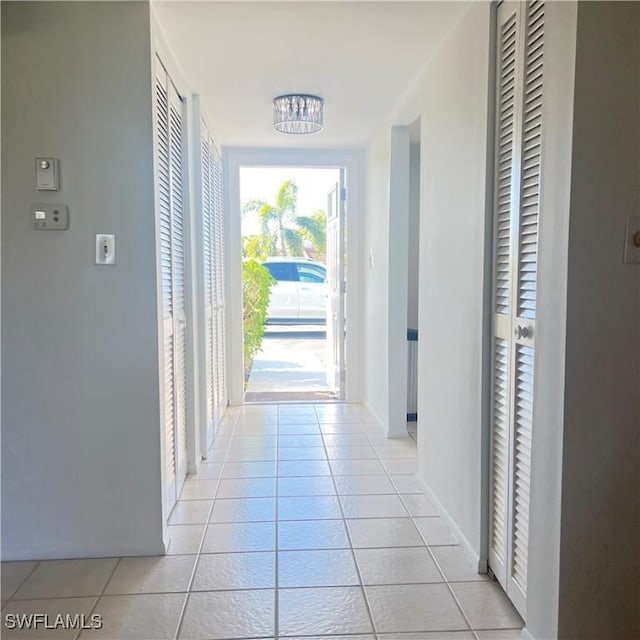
[105,555,196,595]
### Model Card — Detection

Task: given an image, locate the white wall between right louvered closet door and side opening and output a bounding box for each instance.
[418,4,491,558]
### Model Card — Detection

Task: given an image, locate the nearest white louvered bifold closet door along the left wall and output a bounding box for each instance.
[155,60,187,509]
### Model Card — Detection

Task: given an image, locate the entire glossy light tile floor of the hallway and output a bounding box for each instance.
[0,404,522,640]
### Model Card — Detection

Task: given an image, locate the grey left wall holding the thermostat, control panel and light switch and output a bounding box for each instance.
[2,2,163,560]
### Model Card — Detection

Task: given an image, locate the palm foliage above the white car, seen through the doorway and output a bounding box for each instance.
[242,180,327,257]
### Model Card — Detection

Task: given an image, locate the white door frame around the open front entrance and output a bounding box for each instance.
[222,147,364,406]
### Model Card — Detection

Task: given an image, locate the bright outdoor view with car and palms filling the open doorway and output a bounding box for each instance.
[240,167,345,402]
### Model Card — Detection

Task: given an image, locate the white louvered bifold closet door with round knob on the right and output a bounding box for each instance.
[489,2,544,616]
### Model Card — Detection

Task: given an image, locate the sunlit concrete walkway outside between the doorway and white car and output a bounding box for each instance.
[246,325,330,401]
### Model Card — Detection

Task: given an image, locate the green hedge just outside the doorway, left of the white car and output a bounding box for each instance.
[242,260,275,371]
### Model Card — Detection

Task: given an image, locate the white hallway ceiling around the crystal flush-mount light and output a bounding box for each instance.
[153,0,468,147]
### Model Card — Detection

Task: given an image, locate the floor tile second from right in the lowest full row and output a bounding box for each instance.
[365,584,469,633]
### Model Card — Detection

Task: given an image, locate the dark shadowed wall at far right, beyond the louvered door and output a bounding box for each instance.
[558,2,640,640]
